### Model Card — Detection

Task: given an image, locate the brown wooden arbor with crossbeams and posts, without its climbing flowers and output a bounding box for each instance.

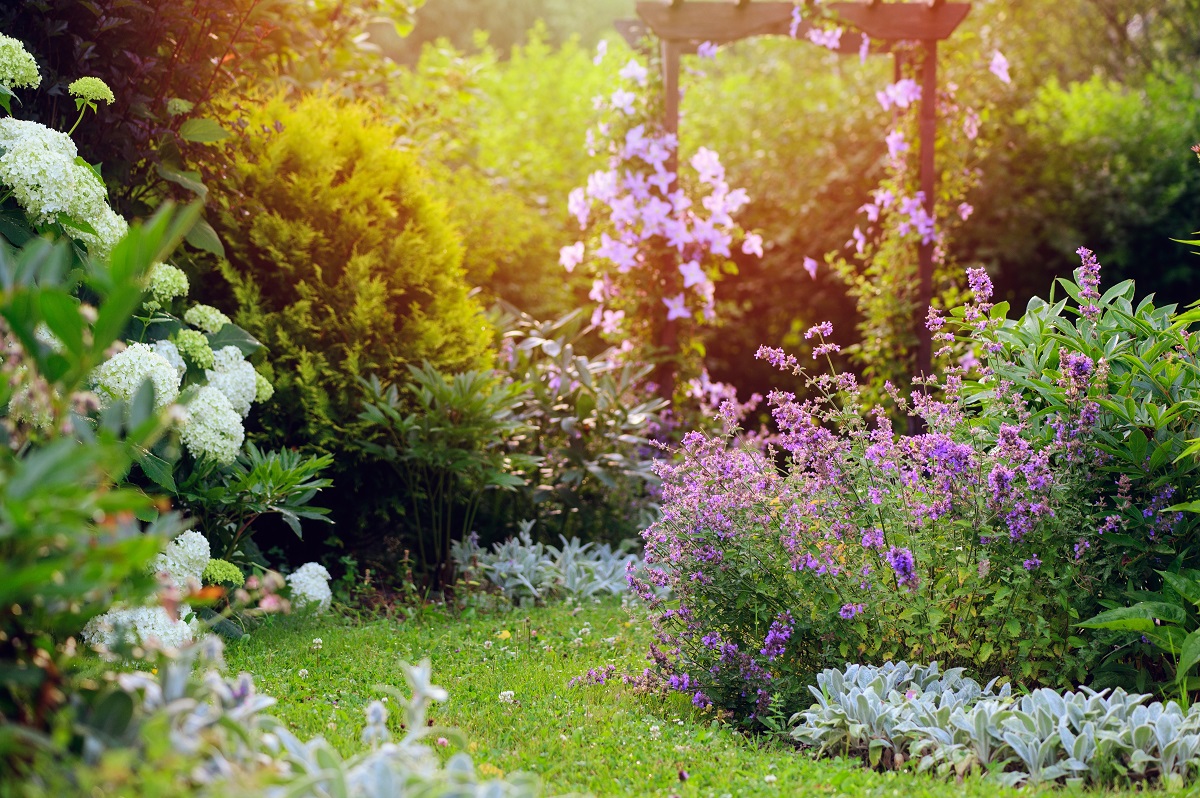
[617,0,971,384]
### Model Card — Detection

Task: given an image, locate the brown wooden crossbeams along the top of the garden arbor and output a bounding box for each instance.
[637,0,971,43]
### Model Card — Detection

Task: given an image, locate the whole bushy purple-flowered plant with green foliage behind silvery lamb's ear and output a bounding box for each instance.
[632,264,1105,721]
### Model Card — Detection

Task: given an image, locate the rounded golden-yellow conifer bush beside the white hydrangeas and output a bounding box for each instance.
[217,95,491,445]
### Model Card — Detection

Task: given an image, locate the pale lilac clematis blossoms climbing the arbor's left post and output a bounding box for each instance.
[559,61,763,340]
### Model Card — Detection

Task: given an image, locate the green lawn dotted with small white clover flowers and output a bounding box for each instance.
[226,600,1180,798]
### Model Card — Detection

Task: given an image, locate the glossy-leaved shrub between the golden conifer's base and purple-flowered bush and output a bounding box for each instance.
[476,302,666,544]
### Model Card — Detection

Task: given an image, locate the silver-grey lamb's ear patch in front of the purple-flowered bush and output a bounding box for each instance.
[791,662,1200,788]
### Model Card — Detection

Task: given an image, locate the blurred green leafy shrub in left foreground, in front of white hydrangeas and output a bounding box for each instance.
[0,209,197,782]
